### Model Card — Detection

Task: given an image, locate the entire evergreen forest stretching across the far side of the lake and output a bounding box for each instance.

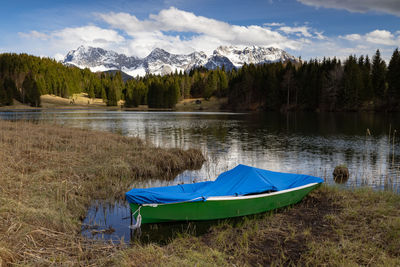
[0,49,400,111]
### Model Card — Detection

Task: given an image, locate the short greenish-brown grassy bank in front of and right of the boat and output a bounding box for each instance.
[119,186,400,266]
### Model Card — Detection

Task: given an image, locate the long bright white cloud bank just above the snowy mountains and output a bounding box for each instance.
[14,8,400,60]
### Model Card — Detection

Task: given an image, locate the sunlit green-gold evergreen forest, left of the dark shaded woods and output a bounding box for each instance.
[0,53,228,108]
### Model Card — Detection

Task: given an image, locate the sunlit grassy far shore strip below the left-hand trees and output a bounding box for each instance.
[0,93,227,111]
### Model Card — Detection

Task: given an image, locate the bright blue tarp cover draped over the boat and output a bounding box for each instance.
[125,165,323,204]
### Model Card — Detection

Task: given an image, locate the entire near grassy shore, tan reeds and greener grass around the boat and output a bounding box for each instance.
[0,121,400,266]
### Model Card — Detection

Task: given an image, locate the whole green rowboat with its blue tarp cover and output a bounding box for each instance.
[126,165,323,223]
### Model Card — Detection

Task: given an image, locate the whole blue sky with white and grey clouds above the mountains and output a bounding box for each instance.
[0,0,400,60]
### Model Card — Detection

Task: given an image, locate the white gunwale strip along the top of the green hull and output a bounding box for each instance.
[139,183,321,207]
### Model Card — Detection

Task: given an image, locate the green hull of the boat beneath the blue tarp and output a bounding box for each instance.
[130,184,320,224]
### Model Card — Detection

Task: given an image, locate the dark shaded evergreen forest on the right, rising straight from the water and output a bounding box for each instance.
[227,49,400,111]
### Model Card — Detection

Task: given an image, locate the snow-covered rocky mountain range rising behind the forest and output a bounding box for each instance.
[63,46,299,77]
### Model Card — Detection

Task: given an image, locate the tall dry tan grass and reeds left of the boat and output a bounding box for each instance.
[0,121,204,266]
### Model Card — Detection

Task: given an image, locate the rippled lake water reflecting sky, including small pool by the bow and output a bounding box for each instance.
[0,110,400,244]
